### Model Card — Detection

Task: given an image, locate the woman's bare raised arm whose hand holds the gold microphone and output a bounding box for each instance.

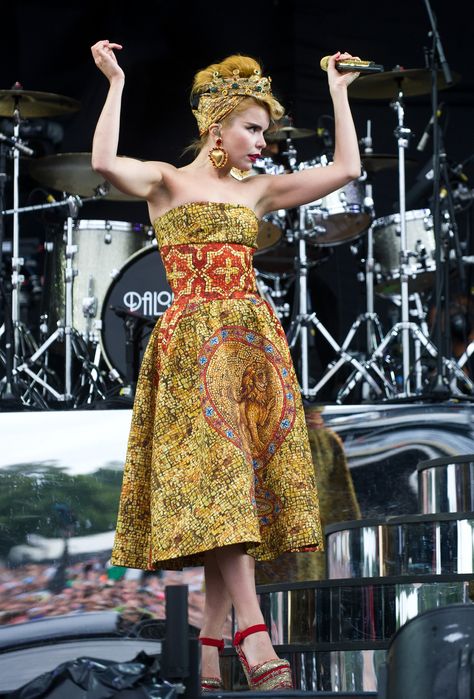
[258,52,361,214]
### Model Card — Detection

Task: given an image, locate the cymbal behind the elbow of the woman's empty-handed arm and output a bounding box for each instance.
[29,153,141,201]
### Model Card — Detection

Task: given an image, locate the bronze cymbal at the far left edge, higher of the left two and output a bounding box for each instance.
[0,89,80,119]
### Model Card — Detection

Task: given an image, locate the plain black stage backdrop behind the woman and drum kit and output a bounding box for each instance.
[0,0,474,378]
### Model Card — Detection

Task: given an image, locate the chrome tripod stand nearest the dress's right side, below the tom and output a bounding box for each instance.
[287,206,382,398]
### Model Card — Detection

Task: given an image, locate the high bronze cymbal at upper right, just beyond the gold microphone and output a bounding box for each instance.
[348,66,461,99]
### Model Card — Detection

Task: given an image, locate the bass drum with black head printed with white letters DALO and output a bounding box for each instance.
[100,244,173,382]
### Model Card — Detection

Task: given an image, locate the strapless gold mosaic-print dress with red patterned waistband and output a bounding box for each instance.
[112,202,322,569]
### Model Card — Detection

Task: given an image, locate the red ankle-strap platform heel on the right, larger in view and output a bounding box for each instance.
[234,624,294,692]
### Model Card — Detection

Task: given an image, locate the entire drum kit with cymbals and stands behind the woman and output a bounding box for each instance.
[0,69,474,408]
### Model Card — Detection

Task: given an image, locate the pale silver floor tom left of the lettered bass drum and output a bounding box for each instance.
[43,220,154,340]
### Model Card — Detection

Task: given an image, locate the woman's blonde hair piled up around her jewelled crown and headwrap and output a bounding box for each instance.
[186,54,285,154]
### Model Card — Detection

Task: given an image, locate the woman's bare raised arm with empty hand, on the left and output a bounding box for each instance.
[91,40,162,200]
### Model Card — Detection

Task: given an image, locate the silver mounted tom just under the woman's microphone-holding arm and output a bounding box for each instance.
[299,159,371,247]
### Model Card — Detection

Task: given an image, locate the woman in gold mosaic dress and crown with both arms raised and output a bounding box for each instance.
[92,40,360,691]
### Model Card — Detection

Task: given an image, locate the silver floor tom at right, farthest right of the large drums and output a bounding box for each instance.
[372,209,436,296]
